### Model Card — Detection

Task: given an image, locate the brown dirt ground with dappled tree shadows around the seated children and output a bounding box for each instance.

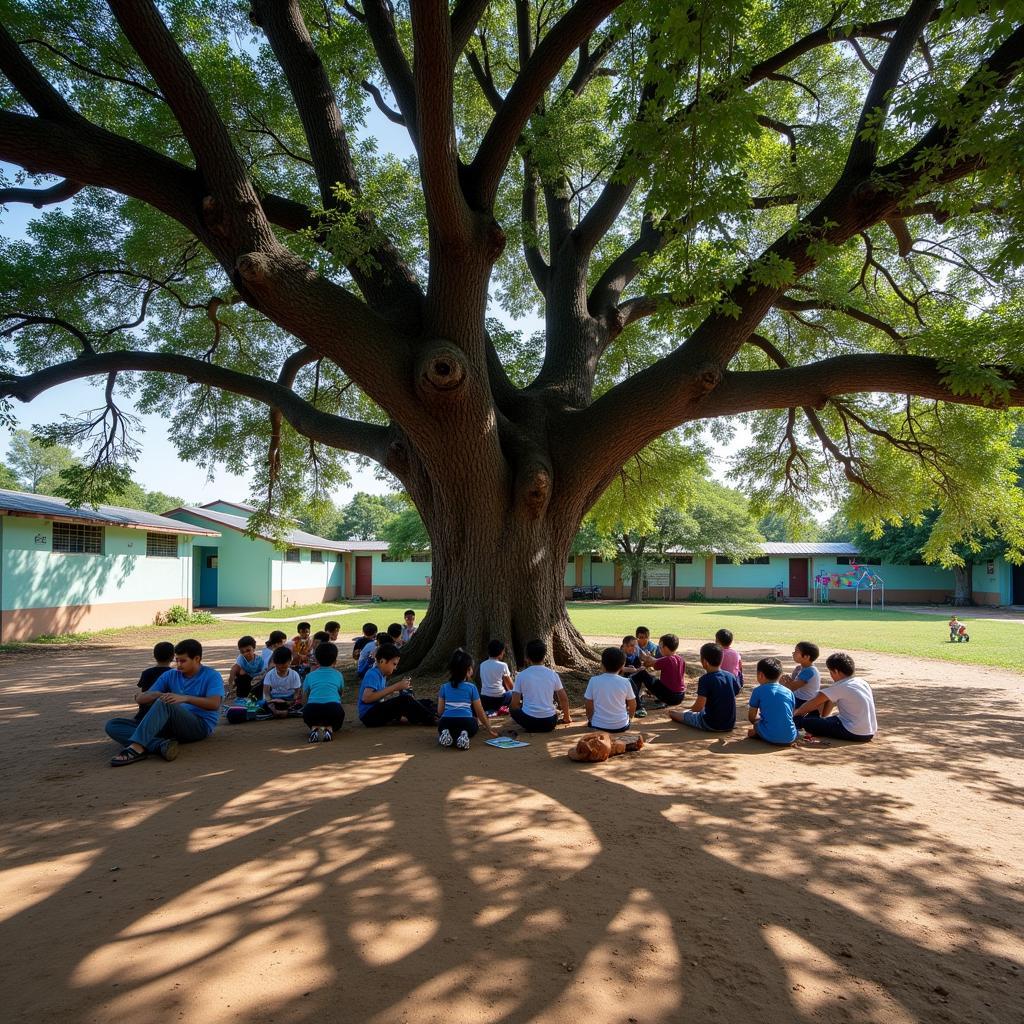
[0,643,1024,1024]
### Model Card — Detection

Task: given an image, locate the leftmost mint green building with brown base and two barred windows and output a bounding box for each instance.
[0,489,217,642]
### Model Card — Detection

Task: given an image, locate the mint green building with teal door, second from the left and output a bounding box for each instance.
[166,500,386,608]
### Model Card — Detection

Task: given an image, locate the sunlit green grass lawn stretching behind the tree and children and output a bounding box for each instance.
[6,600,1024,672]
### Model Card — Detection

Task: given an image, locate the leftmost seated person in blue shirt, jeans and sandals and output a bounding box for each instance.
[105,640,224,768]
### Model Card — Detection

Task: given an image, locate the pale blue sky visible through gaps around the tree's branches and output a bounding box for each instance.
[0,79,744,505]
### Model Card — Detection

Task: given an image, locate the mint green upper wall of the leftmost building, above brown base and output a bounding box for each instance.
[0,516,191,610]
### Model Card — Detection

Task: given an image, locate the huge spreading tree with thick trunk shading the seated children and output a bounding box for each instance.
[0,0,1024,666]
